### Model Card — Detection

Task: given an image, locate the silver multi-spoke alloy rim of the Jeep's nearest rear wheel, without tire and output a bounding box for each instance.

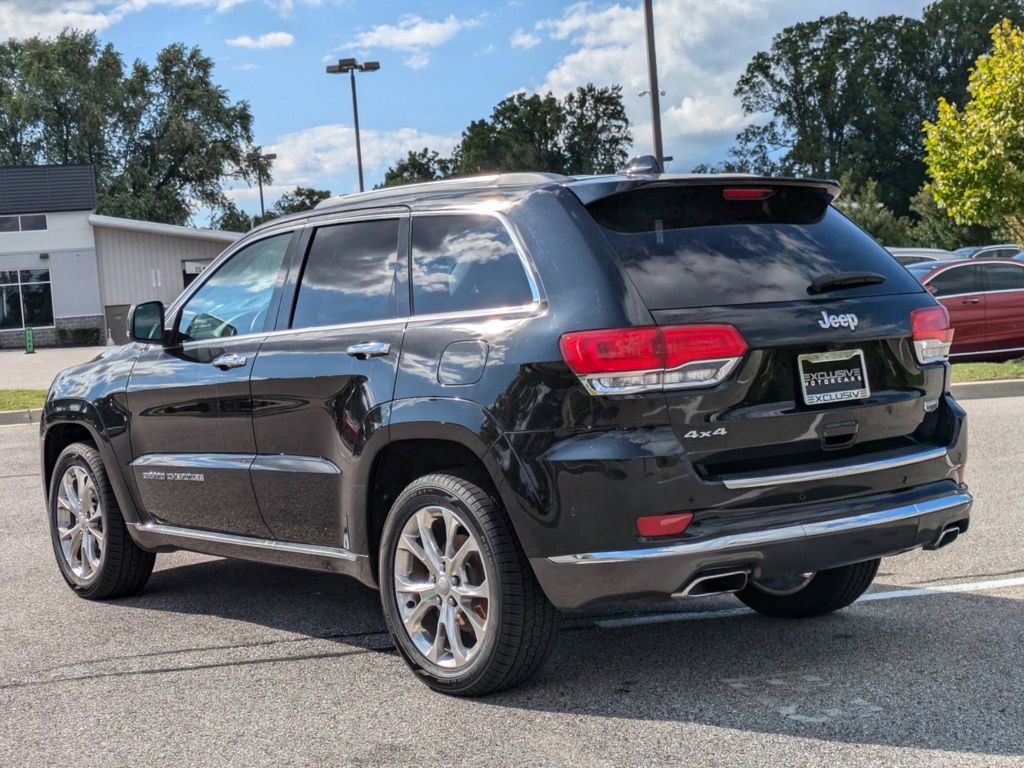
[394,505,494,671]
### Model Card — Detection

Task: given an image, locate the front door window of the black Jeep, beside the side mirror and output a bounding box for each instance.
[178,232,292,341]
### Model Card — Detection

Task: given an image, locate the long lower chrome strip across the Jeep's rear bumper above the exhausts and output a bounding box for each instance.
[547,494,972,564]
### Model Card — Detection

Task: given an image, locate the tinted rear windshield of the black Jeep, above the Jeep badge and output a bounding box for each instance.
[588,185,922,309]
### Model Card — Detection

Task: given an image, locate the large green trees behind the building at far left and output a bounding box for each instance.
[0,30,260,224]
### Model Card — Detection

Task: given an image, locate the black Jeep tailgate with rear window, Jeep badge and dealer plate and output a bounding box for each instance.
[588,181,944,487]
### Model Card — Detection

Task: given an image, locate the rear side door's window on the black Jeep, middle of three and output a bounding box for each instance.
[292,219,399,328]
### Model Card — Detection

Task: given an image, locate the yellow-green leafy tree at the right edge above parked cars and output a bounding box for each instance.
[925,19,1024,243]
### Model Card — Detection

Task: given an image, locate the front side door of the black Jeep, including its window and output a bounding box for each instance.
[128,232,292,537]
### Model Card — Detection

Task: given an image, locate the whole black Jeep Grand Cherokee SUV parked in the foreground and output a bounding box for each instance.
[41,174,971,694]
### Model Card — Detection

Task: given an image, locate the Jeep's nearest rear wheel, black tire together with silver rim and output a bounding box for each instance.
[379,474,557,696]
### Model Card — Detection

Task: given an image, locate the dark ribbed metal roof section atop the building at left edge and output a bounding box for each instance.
[0,165,96,215]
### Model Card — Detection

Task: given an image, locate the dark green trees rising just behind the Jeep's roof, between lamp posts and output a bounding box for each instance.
[384,84,633,186]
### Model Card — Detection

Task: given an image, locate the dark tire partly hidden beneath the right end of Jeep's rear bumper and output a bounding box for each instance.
[736,560,882,618]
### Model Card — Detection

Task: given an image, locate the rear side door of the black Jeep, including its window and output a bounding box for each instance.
[252,209,409,549]
